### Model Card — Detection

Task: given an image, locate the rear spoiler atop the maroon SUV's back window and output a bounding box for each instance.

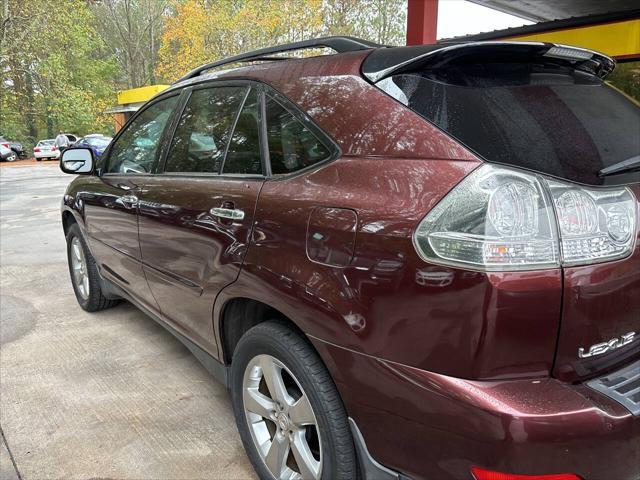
[362,42,616,83]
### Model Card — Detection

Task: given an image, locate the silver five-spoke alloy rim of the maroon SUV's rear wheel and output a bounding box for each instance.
[242,355,322,480]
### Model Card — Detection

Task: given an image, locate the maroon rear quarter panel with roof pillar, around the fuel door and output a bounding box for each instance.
[214,52,562,378]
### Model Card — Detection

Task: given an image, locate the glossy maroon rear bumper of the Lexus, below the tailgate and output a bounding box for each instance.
[312,339,640,480]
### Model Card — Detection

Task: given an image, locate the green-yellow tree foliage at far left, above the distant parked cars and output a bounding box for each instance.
[0,0,116,150]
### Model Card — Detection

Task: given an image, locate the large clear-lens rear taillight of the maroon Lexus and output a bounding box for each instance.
[414,164,636,271]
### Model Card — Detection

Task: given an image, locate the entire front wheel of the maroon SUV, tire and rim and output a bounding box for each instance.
[67,223,118,312]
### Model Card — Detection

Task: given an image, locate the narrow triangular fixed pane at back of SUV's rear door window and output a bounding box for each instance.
[222,89,262,175]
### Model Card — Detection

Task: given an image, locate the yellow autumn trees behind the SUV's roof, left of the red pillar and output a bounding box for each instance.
[156,0,406,81]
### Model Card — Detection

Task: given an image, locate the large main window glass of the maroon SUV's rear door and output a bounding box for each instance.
[165,87,247,173]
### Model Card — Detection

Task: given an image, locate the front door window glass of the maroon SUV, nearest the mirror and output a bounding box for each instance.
[106,96,178,174]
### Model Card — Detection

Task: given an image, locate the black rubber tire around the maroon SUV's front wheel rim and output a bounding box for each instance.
[67,223,119,312]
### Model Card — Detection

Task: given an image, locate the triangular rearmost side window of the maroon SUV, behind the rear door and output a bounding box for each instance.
[266,97,330,175]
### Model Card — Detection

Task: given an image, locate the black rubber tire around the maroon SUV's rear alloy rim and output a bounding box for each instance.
[230,320,358,480]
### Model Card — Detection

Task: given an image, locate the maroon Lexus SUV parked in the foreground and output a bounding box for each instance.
[61,37,640,480]
